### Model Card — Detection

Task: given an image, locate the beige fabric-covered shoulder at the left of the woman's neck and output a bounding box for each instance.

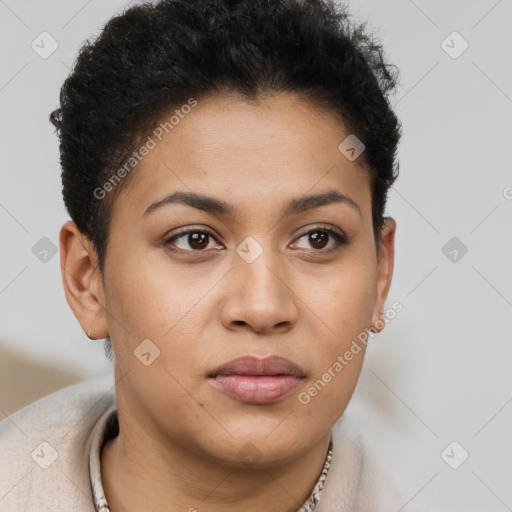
[0,375,115,511]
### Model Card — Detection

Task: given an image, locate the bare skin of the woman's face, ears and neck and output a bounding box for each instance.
[60,93,396,512]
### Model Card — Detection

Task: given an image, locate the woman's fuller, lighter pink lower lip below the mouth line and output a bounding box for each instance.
[209,375,302,404]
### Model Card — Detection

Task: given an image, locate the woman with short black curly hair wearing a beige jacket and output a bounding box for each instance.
[0,0,403,512]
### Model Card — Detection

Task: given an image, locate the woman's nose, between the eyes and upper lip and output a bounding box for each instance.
[221,250,298,334]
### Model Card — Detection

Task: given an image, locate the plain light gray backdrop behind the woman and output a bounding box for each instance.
[0,0,512,512]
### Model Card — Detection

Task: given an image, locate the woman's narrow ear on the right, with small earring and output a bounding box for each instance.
[371,217,396,332]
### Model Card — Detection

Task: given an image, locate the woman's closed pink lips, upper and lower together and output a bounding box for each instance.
[208,356,306,404]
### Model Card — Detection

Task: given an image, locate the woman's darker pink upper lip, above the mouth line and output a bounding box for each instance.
[208,356,306,379]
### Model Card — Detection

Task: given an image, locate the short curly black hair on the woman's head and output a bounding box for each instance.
[50,0,401,284]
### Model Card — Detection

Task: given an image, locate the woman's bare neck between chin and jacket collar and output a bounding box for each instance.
[101,411,330,512]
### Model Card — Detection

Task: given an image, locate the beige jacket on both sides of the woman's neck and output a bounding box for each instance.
[0,377,404,512]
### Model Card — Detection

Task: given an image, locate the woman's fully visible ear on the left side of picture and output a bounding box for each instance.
[59,221,109,339]
